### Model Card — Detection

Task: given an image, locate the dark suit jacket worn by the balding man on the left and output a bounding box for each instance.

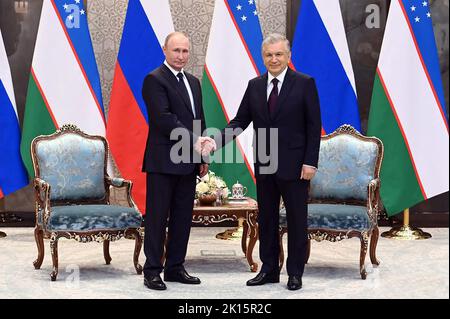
[142,64,205,175]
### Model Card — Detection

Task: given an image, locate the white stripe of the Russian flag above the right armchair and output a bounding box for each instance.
[314,0,356,95]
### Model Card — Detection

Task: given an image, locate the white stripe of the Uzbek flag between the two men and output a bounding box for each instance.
[205,1,257,171]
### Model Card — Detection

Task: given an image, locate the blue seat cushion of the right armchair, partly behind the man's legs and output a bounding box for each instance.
[280,204,370,231]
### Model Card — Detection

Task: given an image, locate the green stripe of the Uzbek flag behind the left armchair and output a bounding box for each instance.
[20,76,56,177]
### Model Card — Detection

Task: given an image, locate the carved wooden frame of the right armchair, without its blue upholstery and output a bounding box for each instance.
[279,124,384,279]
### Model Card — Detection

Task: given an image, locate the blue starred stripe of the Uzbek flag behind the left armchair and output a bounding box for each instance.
[53,0,105,114]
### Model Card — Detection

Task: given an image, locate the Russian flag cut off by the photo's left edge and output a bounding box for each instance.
[0,30,28,198]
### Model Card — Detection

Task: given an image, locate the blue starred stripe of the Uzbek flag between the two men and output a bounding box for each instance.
[225,0,266,74]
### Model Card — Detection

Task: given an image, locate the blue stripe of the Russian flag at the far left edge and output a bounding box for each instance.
[0,80,28,195]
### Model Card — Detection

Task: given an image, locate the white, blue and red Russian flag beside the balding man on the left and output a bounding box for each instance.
[106,0,174,213]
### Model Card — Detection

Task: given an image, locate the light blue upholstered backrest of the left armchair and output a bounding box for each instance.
[31,125,108,202]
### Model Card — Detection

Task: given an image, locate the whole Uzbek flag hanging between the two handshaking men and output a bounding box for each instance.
[202,0,266,198]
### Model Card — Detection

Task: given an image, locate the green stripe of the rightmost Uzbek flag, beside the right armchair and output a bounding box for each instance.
[367,74,424,216]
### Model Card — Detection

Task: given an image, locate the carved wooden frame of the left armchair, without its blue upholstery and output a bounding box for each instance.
[31,124,143,281]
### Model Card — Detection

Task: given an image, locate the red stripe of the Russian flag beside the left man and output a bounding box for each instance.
[106,63,148,215]
